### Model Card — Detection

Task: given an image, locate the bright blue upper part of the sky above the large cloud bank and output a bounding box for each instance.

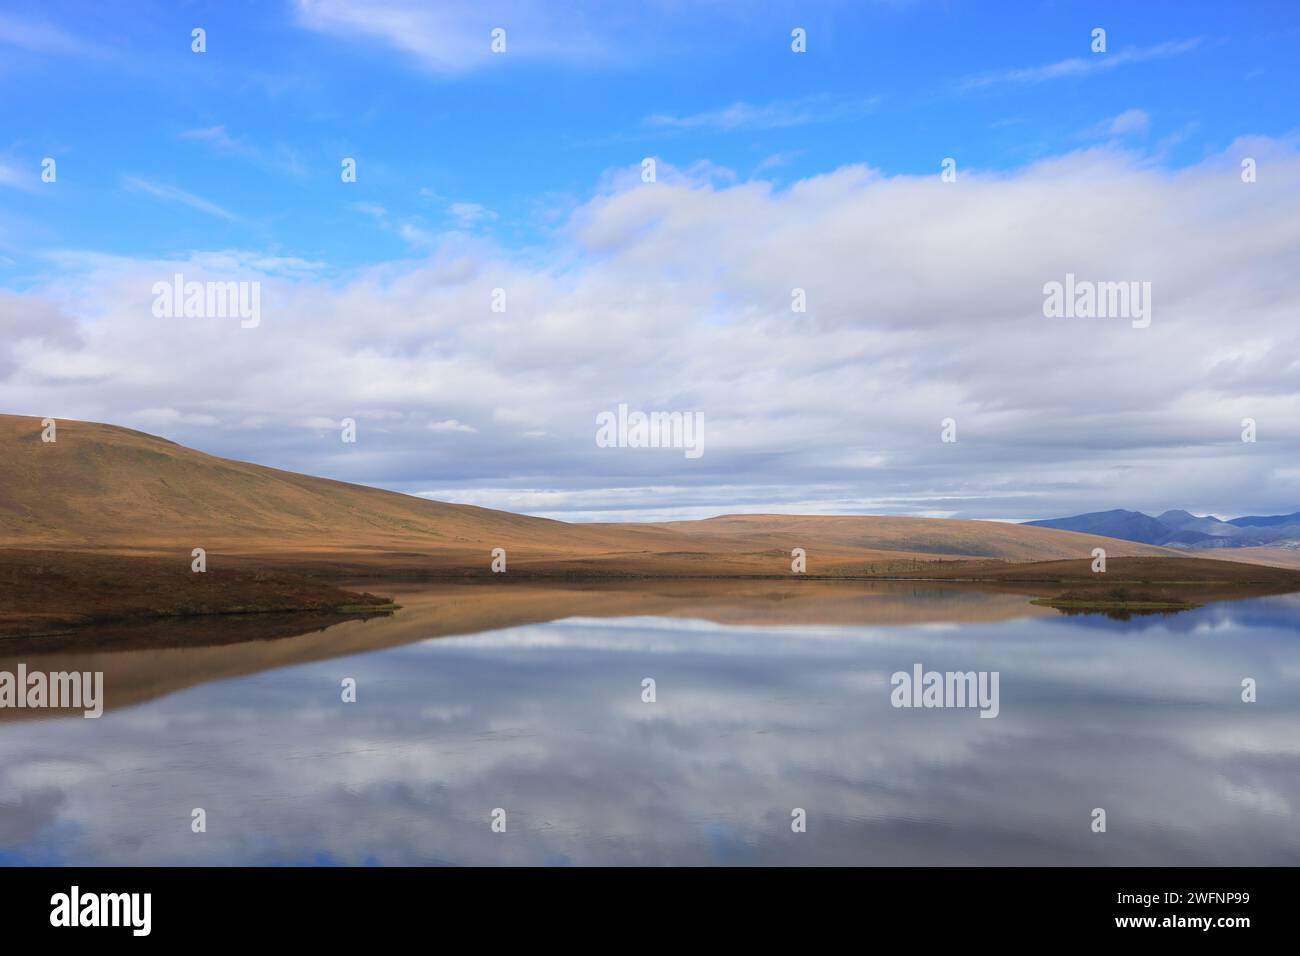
[0,3,1300,274]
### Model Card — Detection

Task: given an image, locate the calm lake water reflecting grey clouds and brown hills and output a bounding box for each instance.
[0,587,1300,865]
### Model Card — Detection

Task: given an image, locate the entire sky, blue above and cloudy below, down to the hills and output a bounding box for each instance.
[0,0,1300,520]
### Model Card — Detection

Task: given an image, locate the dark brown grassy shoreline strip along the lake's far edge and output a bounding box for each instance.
[0,549,1300,637]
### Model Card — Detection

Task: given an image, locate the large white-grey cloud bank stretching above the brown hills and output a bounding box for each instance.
[10,139,1300,518]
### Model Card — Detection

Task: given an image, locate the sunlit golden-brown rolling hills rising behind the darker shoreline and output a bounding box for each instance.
[0,415,1170,578]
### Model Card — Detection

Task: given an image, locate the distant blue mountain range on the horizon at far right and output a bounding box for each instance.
[1026,509,1300,550]
